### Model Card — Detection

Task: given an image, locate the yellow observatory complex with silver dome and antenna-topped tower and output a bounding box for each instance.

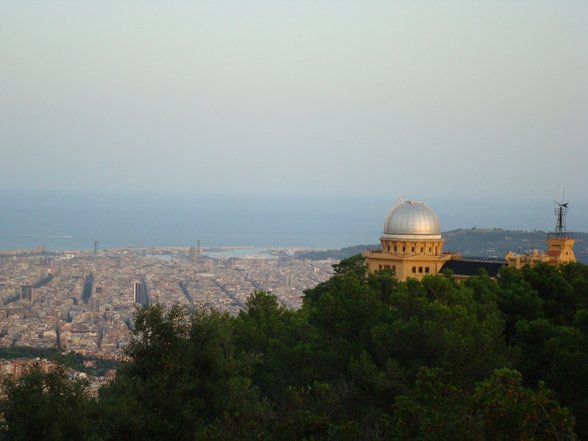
[364,199,576,281]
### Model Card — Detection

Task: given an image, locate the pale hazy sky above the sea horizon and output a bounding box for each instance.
[0,0,588,201]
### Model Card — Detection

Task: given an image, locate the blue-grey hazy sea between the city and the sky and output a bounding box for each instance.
[0,192,588,251]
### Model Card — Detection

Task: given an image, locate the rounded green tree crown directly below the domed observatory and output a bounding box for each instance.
[381,276,507,386]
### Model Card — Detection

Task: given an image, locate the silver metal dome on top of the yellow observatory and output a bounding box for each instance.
[384,199,441,239]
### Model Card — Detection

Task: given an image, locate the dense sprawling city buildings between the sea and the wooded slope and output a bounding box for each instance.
[0,249,335,358]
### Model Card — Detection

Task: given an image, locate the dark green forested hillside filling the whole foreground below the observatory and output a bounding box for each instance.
[0,256,588,441]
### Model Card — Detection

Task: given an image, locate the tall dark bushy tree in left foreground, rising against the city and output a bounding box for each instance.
[101,305,271,440]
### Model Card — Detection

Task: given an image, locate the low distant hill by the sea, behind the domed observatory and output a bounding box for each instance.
[297,227,588,264]
